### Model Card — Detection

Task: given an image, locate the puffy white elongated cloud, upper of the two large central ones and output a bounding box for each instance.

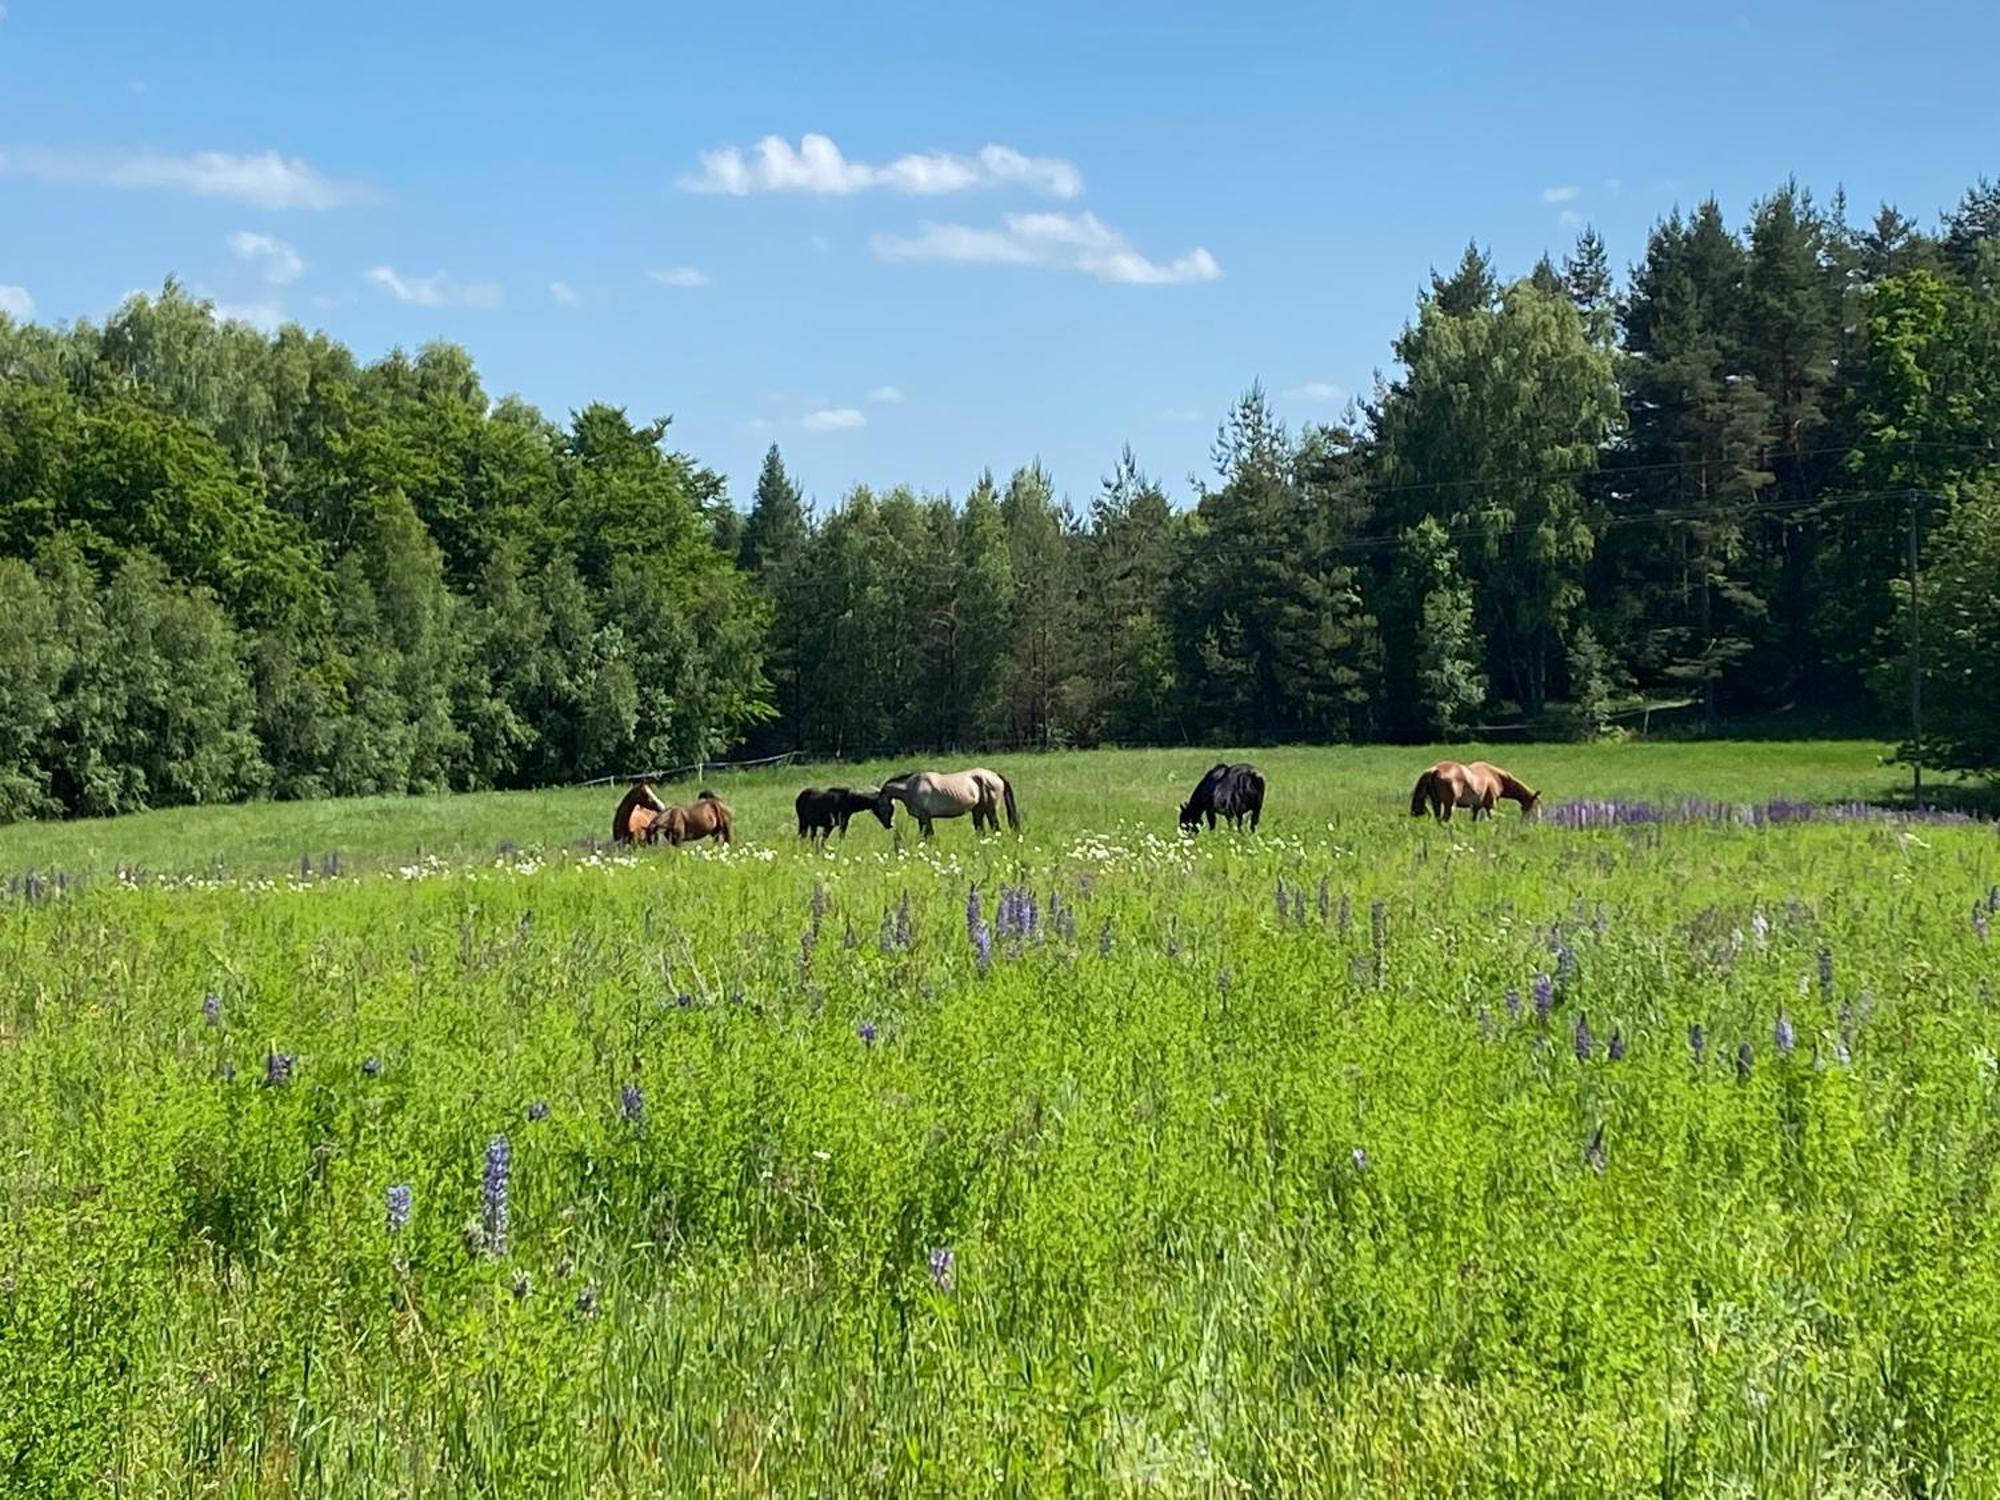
[680,132,1084,198]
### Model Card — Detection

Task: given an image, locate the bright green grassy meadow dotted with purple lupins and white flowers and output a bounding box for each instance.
[0,744,2000,1496]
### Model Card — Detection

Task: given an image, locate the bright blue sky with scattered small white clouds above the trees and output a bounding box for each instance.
[0,0,2000,504]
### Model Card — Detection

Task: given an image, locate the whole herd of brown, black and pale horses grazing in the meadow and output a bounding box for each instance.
[612,760,1542,844]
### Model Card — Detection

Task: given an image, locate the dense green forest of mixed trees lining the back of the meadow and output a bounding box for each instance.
[0,180,2000,820]
